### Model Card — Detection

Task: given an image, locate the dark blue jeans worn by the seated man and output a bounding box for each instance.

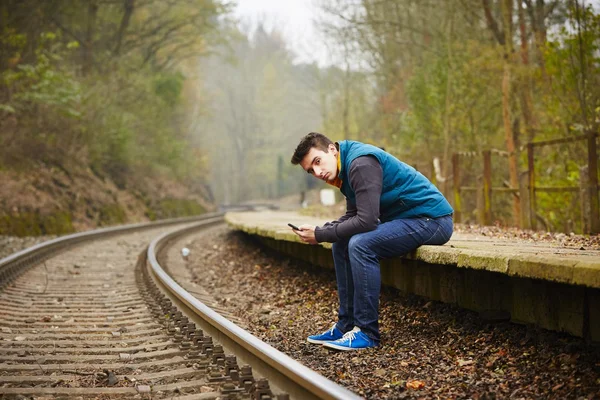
[333,215,453,343]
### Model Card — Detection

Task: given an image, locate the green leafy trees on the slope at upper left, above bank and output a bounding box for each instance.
[0,0,232,188]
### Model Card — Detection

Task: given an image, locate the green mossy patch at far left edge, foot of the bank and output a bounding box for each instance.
[0,211,75,236]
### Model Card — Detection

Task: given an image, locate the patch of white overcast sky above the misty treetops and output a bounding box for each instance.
[235,0,330,65]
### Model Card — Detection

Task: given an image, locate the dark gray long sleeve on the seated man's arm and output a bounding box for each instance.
[315,156,383,243]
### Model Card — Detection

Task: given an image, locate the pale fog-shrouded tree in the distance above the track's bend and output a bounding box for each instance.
[197,25,321,203]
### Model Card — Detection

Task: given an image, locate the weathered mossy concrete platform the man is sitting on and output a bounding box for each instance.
[225,211,600,342]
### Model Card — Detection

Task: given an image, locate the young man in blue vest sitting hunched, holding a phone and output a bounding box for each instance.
[291,132,453,350]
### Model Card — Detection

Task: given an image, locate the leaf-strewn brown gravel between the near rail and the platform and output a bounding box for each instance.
[187,227,600,399]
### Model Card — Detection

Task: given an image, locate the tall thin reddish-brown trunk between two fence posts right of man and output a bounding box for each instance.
[502,0,521,226]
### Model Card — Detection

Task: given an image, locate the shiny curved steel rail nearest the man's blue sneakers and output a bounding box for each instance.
[147,220,362,400]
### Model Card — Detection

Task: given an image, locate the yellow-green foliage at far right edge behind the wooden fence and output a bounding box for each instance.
[524,3,600,232]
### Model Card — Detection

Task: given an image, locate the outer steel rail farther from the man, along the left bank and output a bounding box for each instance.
[0,213,224,290]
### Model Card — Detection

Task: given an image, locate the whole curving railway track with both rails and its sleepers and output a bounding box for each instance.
[0,214,358,400]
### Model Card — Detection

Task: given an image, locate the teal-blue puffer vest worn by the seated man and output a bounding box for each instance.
[339,140,454,222]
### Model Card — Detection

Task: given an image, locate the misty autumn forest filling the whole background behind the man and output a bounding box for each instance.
[0,0,600,234]
